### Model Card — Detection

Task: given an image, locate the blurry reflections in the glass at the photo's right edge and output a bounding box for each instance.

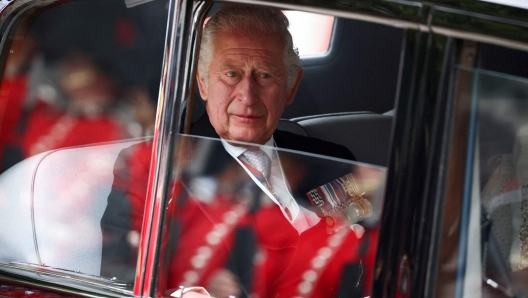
[464,45,528,296]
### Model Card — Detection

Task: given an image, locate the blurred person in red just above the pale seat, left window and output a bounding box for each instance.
[22,53,126,157]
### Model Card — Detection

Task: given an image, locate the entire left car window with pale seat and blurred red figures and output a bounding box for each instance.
[0,0,168,293]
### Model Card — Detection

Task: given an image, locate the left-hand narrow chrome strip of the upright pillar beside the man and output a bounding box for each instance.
[134,0,183,296]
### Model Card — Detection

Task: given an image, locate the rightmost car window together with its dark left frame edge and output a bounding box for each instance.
[437,43,528,297]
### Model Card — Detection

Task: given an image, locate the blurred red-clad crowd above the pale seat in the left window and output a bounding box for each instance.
[0,1,167,173]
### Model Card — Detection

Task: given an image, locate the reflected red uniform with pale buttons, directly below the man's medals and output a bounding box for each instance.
[252,208,377,297]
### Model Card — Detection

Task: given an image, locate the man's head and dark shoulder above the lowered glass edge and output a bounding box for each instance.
[191,5,355,160]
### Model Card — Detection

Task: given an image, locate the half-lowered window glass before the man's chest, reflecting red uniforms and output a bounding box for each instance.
[146,135,385,297]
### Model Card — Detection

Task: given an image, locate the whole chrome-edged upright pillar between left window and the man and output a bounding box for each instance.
[134,0,204,297]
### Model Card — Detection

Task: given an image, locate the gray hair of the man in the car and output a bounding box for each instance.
[198,4,301,90]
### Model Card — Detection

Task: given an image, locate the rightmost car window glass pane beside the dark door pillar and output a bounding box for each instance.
[465,44,528,296]
